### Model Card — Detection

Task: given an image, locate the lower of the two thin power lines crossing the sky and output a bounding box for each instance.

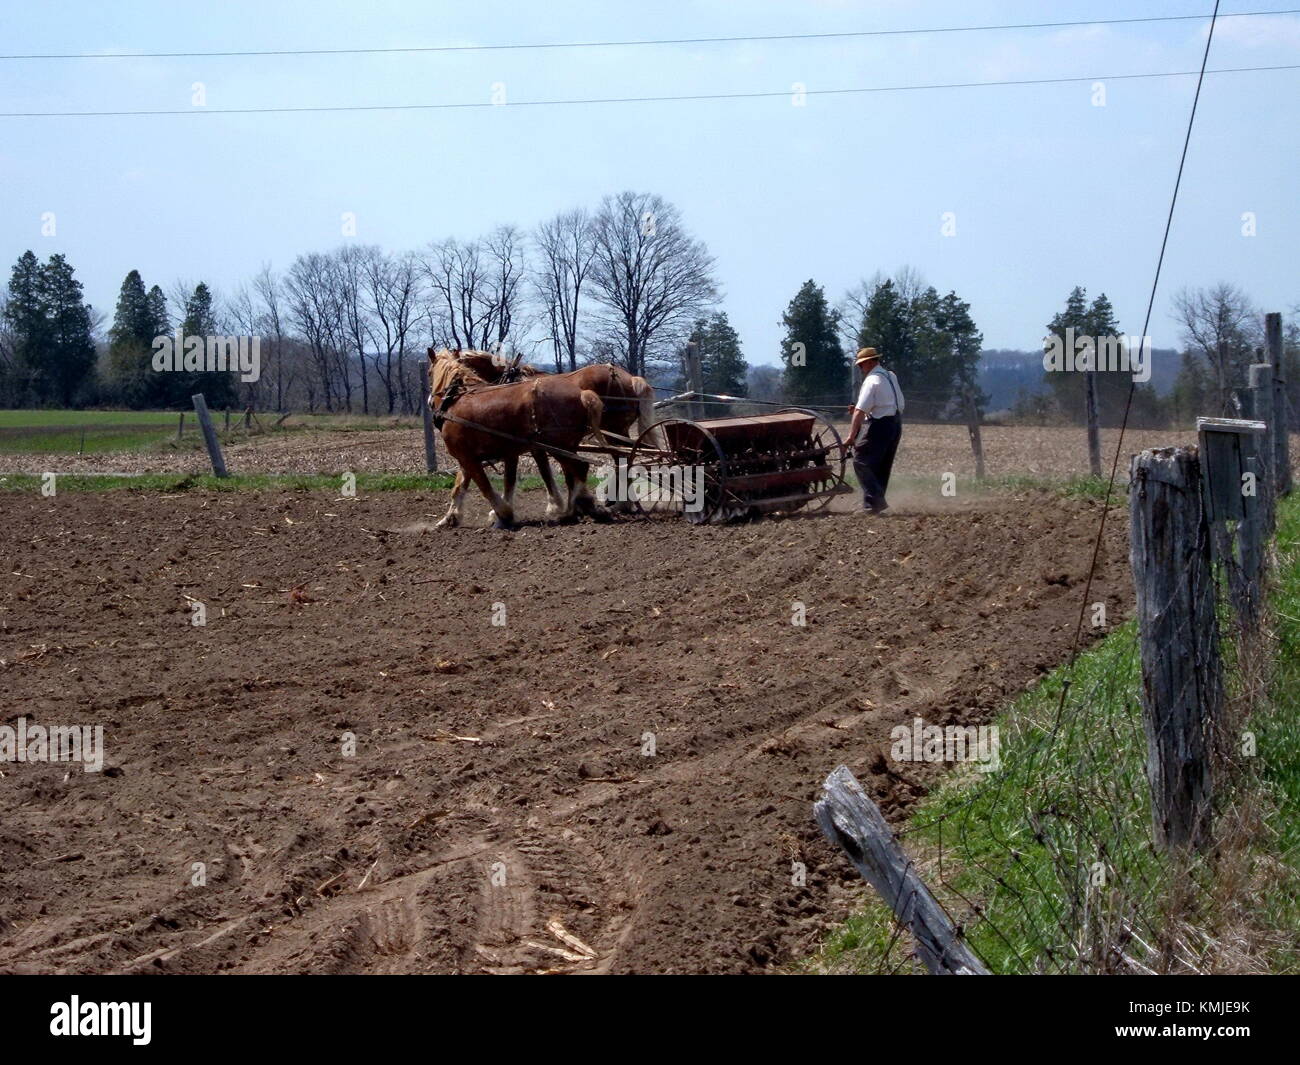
[0,64,1300,118]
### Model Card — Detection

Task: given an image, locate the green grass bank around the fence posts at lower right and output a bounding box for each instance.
[805,498,1300,973]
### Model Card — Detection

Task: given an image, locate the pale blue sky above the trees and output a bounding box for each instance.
[0,0,1300,363]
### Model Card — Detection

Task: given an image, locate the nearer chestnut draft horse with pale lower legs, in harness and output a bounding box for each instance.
[429,348,605,528]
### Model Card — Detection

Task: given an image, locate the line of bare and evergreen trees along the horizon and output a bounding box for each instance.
[0,191,1300,425]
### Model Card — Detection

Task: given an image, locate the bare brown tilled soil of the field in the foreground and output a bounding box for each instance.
[0,492,1128,973]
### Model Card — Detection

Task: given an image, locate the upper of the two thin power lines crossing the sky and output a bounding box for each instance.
[0,8,1300,60]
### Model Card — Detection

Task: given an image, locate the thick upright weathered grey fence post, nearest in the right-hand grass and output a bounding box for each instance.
[1128,447,1223,849]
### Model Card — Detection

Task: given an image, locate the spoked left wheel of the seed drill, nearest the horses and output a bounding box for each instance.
[629,417,727,525]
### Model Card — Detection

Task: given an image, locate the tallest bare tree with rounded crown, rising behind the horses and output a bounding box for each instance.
[592,192,718,376]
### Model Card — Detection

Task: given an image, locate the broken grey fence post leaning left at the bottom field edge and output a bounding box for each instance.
[813,766,988,977]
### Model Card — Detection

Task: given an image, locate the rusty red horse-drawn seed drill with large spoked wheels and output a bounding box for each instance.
[618,407,853,524]
